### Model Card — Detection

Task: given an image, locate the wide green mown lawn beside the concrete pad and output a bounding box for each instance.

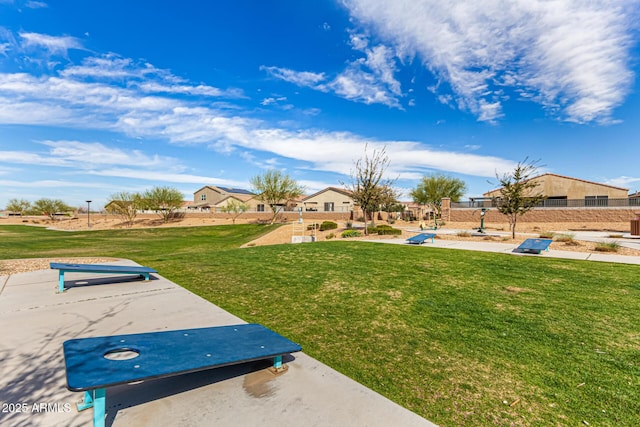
[0,225,640,427]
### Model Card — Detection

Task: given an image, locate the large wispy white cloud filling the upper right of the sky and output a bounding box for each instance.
[344,0,638,123]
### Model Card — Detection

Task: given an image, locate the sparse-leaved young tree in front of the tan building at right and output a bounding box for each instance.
[495,158,545,239]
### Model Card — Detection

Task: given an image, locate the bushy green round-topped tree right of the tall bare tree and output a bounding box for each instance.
[410,174,467,218]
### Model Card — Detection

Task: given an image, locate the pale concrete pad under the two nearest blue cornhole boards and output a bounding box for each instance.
[0,260,434,427]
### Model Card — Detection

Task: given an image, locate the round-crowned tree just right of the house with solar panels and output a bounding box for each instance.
[250,169,304,224]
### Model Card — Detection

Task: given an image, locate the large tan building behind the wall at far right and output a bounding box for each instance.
[484,173,629,206]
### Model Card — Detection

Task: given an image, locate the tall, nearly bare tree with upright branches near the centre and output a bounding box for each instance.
[341,146,395,234]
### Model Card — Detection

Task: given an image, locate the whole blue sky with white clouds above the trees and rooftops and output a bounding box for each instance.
[0,0,640,207]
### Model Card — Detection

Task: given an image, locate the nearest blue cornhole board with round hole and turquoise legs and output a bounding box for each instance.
[63,324,302,427]
